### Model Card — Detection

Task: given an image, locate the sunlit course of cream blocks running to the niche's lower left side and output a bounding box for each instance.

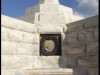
[1,41,39,56]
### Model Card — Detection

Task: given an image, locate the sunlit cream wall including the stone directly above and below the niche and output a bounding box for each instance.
[1,15,64,75]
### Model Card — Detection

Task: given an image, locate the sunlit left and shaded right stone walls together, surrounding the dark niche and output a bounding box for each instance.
[1,15,98,75]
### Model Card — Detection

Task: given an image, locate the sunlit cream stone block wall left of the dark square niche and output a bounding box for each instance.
[1,15,39,75]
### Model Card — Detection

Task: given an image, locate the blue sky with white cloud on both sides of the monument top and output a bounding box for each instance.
[1,0,99,18]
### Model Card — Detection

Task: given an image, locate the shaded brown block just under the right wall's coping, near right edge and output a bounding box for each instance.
[79,30,94,42]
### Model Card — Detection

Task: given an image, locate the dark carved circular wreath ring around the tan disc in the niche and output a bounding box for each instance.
[40,36,59,56]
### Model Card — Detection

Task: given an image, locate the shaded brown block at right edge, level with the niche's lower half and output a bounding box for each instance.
[86,42,99,55]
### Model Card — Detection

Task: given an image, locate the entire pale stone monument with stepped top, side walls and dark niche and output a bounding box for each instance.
[1,0,98,75]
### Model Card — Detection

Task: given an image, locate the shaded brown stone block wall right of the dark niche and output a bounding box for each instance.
[62,16,99,75]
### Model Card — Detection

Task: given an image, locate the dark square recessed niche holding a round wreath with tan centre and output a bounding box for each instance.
[40,34,62,56]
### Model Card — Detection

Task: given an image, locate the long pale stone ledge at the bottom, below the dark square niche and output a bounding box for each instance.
[26,68,73,75]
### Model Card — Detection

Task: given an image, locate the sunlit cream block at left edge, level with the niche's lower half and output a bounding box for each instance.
[1,41,16,55]
